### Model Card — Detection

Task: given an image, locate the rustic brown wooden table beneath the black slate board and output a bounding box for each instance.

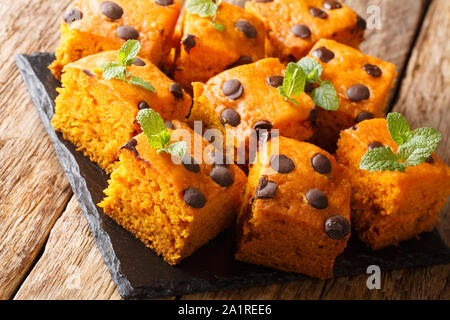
[0,0,450,299]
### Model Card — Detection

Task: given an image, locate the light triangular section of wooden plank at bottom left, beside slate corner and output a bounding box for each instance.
[14,197,121,300]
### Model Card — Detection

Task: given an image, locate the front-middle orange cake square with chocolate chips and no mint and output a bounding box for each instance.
[235,137,350,279]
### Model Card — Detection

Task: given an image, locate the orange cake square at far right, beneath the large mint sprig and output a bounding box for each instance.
[336,119,450,249]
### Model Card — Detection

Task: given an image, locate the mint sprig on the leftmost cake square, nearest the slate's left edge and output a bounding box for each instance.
[100,40,156,92]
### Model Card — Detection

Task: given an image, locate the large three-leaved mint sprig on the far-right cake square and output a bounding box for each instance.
[359,112,442,172]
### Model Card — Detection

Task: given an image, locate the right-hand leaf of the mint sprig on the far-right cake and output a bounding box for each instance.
[397,128,442,166]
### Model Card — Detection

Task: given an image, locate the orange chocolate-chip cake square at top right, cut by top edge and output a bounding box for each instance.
[245,0,366,61]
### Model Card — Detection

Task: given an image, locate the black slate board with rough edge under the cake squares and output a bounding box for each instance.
[15,52,450,299]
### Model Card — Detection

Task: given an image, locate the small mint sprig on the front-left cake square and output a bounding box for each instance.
[136,109,187,159]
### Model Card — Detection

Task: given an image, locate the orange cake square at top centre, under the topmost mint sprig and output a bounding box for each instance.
[174,1,265,88]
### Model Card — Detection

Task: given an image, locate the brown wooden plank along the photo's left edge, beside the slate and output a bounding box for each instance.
[0,0,72,299]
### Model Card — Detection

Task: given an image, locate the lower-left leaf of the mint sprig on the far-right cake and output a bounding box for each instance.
[359,147,406,172]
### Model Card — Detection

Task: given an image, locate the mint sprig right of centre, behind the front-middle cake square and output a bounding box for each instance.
[278,57,339,111]
